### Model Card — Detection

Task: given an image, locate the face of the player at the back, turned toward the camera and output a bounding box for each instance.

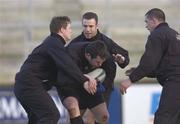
[82,19,98,39]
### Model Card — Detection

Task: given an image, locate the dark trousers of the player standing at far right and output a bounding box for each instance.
[154,80,180,124]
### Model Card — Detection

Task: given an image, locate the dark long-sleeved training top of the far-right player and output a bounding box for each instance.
[129,23,180,85]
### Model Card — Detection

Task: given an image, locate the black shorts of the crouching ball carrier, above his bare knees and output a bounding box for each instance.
[57,86,105,109]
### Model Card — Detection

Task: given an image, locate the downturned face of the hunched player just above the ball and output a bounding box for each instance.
[88,56,105,68]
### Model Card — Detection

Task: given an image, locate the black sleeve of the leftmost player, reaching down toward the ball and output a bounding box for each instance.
[48,40,88,84]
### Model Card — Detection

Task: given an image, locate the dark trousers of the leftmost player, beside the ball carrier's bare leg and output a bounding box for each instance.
[19,87,60,120]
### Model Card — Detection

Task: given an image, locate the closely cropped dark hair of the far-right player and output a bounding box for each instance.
[145,8,166,21]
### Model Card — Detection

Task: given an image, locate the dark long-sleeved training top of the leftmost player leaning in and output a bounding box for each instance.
[16,33,88,87]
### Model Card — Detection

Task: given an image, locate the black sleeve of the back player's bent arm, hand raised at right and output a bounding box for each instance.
[104,37,129,68]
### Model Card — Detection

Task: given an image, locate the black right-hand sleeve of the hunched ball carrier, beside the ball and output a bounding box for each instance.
[102,58,116,89]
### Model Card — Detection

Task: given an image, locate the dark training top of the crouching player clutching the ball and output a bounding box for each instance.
[58,42,116,87]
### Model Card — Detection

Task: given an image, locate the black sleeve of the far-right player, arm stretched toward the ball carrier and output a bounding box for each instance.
[129,36,163,82]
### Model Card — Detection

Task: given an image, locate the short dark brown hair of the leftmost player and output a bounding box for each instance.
[50,16,71,33]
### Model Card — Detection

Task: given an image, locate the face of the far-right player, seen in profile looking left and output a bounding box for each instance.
[145,17,156,32]
